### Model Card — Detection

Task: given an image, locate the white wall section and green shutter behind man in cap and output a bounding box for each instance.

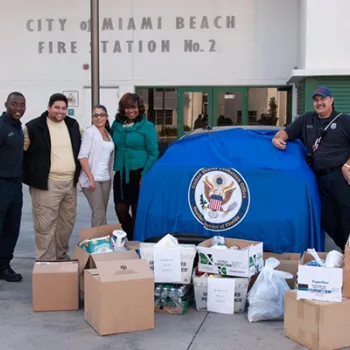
[288,0,350,114]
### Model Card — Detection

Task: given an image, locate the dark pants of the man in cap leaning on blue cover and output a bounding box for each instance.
[317,169,350,251]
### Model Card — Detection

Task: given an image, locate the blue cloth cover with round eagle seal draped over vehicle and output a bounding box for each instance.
[135,128,325,253]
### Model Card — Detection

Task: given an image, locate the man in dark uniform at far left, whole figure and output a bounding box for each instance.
[0,92,26,282]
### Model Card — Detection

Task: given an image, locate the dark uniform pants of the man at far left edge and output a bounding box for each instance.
[0,179,23,270]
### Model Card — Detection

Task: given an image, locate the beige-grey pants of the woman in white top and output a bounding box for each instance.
[83,180,111,227]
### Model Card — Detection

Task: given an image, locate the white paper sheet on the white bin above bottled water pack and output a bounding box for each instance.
[153,247,181,283]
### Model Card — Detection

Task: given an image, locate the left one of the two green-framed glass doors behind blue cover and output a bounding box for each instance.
[177,87,213,137]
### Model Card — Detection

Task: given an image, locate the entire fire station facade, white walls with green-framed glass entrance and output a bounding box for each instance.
[0,0,350,138]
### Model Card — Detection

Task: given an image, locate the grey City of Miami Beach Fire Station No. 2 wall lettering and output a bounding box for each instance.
[25,15,235,54]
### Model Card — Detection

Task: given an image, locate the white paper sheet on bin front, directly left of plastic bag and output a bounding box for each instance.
[207,278,235,315]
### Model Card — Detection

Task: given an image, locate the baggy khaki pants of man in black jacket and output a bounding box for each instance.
[30,180,77,261]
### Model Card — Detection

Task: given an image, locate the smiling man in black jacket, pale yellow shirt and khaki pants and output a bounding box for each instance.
[23,93,81,260]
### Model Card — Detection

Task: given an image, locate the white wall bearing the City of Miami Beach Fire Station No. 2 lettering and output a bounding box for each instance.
[0,0,298,126]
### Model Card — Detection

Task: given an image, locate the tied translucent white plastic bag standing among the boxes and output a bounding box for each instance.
[248,258,293,322]
